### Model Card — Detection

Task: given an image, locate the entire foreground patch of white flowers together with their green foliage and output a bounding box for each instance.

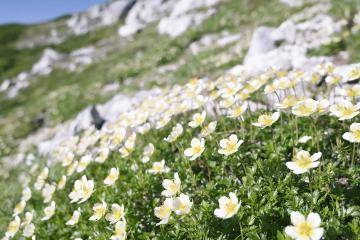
[4,63,360,240]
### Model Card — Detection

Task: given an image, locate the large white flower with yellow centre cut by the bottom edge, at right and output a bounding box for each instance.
[285,212,324,240]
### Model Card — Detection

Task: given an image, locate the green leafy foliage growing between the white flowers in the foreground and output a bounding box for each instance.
[1,113,360,240]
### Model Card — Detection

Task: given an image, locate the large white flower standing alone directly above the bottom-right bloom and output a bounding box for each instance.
[286,150,321,174]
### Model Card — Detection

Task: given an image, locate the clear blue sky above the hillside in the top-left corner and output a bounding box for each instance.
[0,0,106,24]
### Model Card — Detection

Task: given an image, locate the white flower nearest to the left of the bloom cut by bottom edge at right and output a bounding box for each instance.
[214,192,241,219]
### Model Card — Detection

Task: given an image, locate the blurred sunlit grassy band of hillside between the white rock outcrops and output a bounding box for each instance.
[0,0,295,155]
